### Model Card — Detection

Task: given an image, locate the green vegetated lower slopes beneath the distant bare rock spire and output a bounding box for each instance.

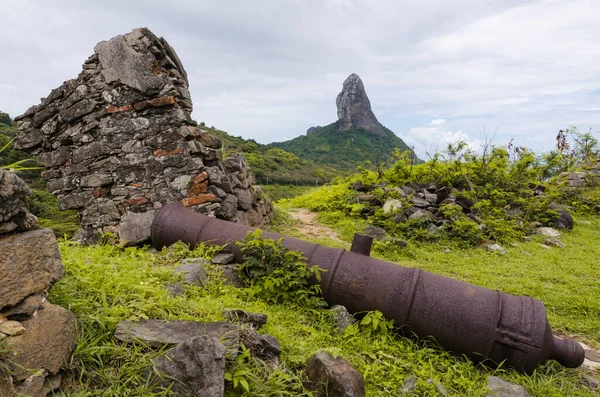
[268,122,418,171]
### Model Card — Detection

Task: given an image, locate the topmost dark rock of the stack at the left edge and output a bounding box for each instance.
[0,168,40,235]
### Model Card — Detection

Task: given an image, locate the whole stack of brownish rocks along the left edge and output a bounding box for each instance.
[0,169,76,397]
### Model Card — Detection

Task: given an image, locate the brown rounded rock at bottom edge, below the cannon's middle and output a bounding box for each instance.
[305,352,366,397]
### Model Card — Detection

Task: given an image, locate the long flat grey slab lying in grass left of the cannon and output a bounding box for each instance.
[115,320,240,347]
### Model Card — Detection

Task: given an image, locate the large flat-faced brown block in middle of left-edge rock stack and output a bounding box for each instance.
[0,229,64,310]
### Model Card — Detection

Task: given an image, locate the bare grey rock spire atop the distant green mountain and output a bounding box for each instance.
[335,73,385,136]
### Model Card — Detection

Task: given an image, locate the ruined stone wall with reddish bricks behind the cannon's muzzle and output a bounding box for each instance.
[15,28,272,244]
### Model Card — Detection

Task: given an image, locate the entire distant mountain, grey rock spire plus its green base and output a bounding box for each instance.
[269,73,411,170]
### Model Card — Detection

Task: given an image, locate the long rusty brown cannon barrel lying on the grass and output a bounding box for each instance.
[152,203,584,373]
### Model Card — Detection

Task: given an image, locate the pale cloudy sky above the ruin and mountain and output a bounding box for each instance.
[0,0,600,156]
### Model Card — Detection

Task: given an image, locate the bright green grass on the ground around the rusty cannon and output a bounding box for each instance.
[38,209,600,397]
